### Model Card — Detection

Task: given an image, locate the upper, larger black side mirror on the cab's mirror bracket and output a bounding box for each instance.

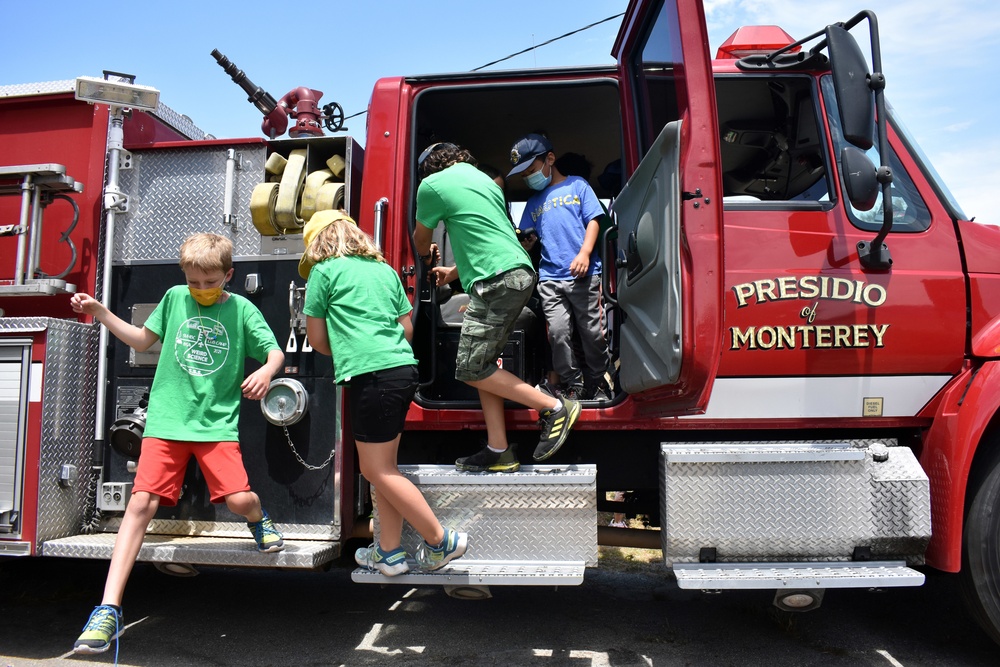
[826,25,875,150]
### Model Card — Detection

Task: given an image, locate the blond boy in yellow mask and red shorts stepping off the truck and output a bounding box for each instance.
[70,234,285,653]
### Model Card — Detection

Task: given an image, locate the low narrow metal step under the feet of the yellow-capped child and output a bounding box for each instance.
[351,558,586,586]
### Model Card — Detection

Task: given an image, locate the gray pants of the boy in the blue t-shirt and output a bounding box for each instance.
[538,275,608,386]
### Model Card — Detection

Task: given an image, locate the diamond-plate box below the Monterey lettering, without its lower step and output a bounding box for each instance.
[661,441,930,563]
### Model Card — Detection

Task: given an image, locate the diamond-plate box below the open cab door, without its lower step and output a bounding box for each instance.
[372,466,597,566]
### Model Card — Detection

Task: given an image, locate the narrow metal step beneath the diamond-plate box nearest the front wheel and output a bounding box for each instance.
[673,561,924,590]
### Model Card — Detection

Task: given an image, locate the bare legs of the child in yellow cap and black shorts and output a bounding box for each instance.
[357,436,444,552]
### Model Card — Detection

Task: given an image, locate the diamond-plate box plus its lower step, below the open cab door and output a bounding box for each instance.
[352,465,597,586]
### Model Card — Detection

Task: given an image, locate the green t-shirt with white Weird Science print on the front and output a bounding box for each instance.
[137,285,281,442]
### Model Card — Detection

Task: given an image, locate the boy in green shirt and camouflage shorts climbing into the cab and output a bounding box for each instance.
[413,143,580,472]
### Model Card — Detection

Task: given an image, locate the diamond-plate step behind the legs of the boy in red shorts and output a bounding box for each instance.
[41,533,340,569]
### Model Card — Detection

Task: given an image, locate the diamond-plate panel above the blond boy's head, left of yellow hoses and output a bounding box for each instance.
[112,143,266,264]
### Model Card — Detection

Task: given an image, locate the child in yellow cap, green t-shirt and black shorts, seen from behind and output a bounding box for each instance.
[299,211,469,577]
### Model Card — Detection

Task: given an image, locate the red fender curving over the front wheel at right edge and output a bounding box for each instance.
[920,361,1000,572]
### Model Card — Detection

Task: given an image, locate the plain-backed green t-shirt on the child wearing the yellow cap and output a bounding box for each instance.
[302,257,417,382]
